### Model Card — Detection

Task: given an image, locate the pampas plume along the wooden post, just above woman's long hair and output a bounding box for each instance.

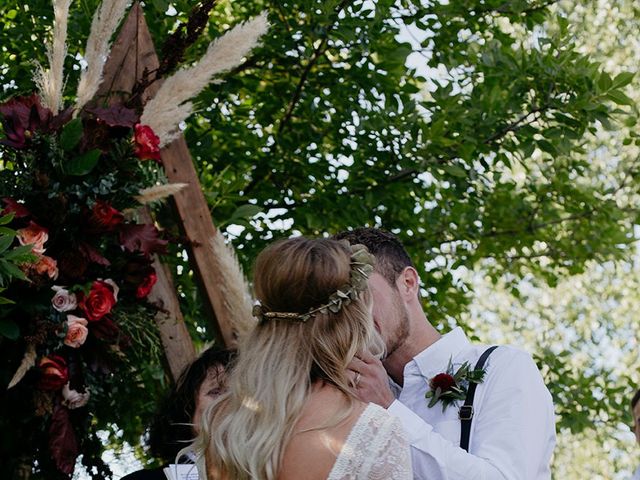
[211,231,256,338]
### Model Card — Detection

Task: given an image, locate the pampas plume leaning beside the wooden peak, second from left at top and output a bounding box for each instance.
[75,0,129,112]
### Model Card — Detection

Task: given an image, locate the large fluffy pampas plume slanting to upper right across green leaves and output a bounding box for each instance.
[140,13,269,147]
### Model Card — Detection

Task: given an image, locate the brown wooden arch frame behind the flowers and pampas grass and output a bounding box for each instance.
[97,1,240,376]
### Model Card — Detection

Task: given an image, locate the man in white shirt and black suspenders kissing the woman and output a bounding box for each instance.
[335,228,555,480]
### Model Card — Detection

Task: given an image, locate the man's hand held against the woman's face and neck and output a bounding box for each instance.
[347,352,395,408]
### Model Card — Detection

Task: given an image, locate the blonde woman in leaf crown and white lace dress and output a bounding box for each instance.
[197,238,412,480]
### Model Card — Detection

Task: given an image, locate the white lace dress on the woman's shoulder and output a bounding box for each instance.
[327,404,413,480]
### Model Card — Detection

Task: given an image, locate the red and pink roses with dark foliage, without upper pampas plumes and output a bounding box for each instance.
[0,90,167,473]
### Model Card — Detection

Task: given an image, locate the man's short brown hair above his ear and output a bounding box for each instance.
[334,227,415,287]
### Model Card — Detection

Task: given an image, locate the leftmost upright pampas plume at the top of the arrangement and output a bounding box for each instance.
[33,0,71,114]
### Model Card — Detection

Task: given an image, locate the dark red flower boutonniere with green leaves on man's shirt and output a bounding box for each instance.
[424,360,486,412]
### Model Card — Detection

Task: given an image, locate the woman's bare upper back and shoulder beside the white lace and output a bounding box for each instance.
[278,385,366,480]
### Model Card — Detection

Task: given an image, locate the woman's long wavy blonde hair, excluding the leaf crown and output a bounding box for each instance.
[197,237,384,480]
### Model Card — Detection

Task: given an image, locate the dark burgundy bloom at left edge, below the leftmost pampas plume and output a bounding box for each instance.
[0,94,53,148]
